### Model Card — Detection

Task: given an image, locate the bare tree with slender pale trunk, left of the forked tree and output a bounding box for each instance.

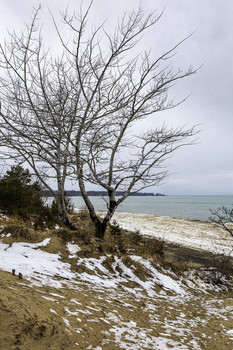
[0,8,77,228]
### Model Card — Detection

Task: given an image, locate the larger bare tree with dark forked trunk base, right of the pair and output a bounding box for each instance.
[56,7,196,238]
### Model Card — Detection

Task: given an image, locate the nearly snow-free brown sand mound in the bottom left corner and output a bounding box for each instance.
[0,271,72,350]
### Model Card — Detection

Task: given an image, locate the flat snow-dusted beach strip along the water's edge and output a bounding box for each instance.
[110,212,233,256]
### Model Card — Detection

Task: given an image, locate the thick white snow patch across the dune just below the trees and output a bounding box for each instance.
[0,232,185,296]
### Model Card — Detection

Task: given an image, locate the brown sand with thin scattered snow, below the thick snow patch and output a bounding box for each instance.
[0,266,233,350]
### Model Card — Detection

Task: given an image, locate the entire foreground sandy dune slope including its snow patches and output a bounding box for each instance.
[0,216,233,350]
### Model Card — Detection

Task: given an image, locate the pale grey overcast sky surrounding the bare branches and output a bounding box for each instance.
[0,0,233,195]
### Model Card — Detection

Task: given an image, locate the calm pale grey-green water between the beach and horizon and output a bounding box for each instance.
[71,196,233,220]
